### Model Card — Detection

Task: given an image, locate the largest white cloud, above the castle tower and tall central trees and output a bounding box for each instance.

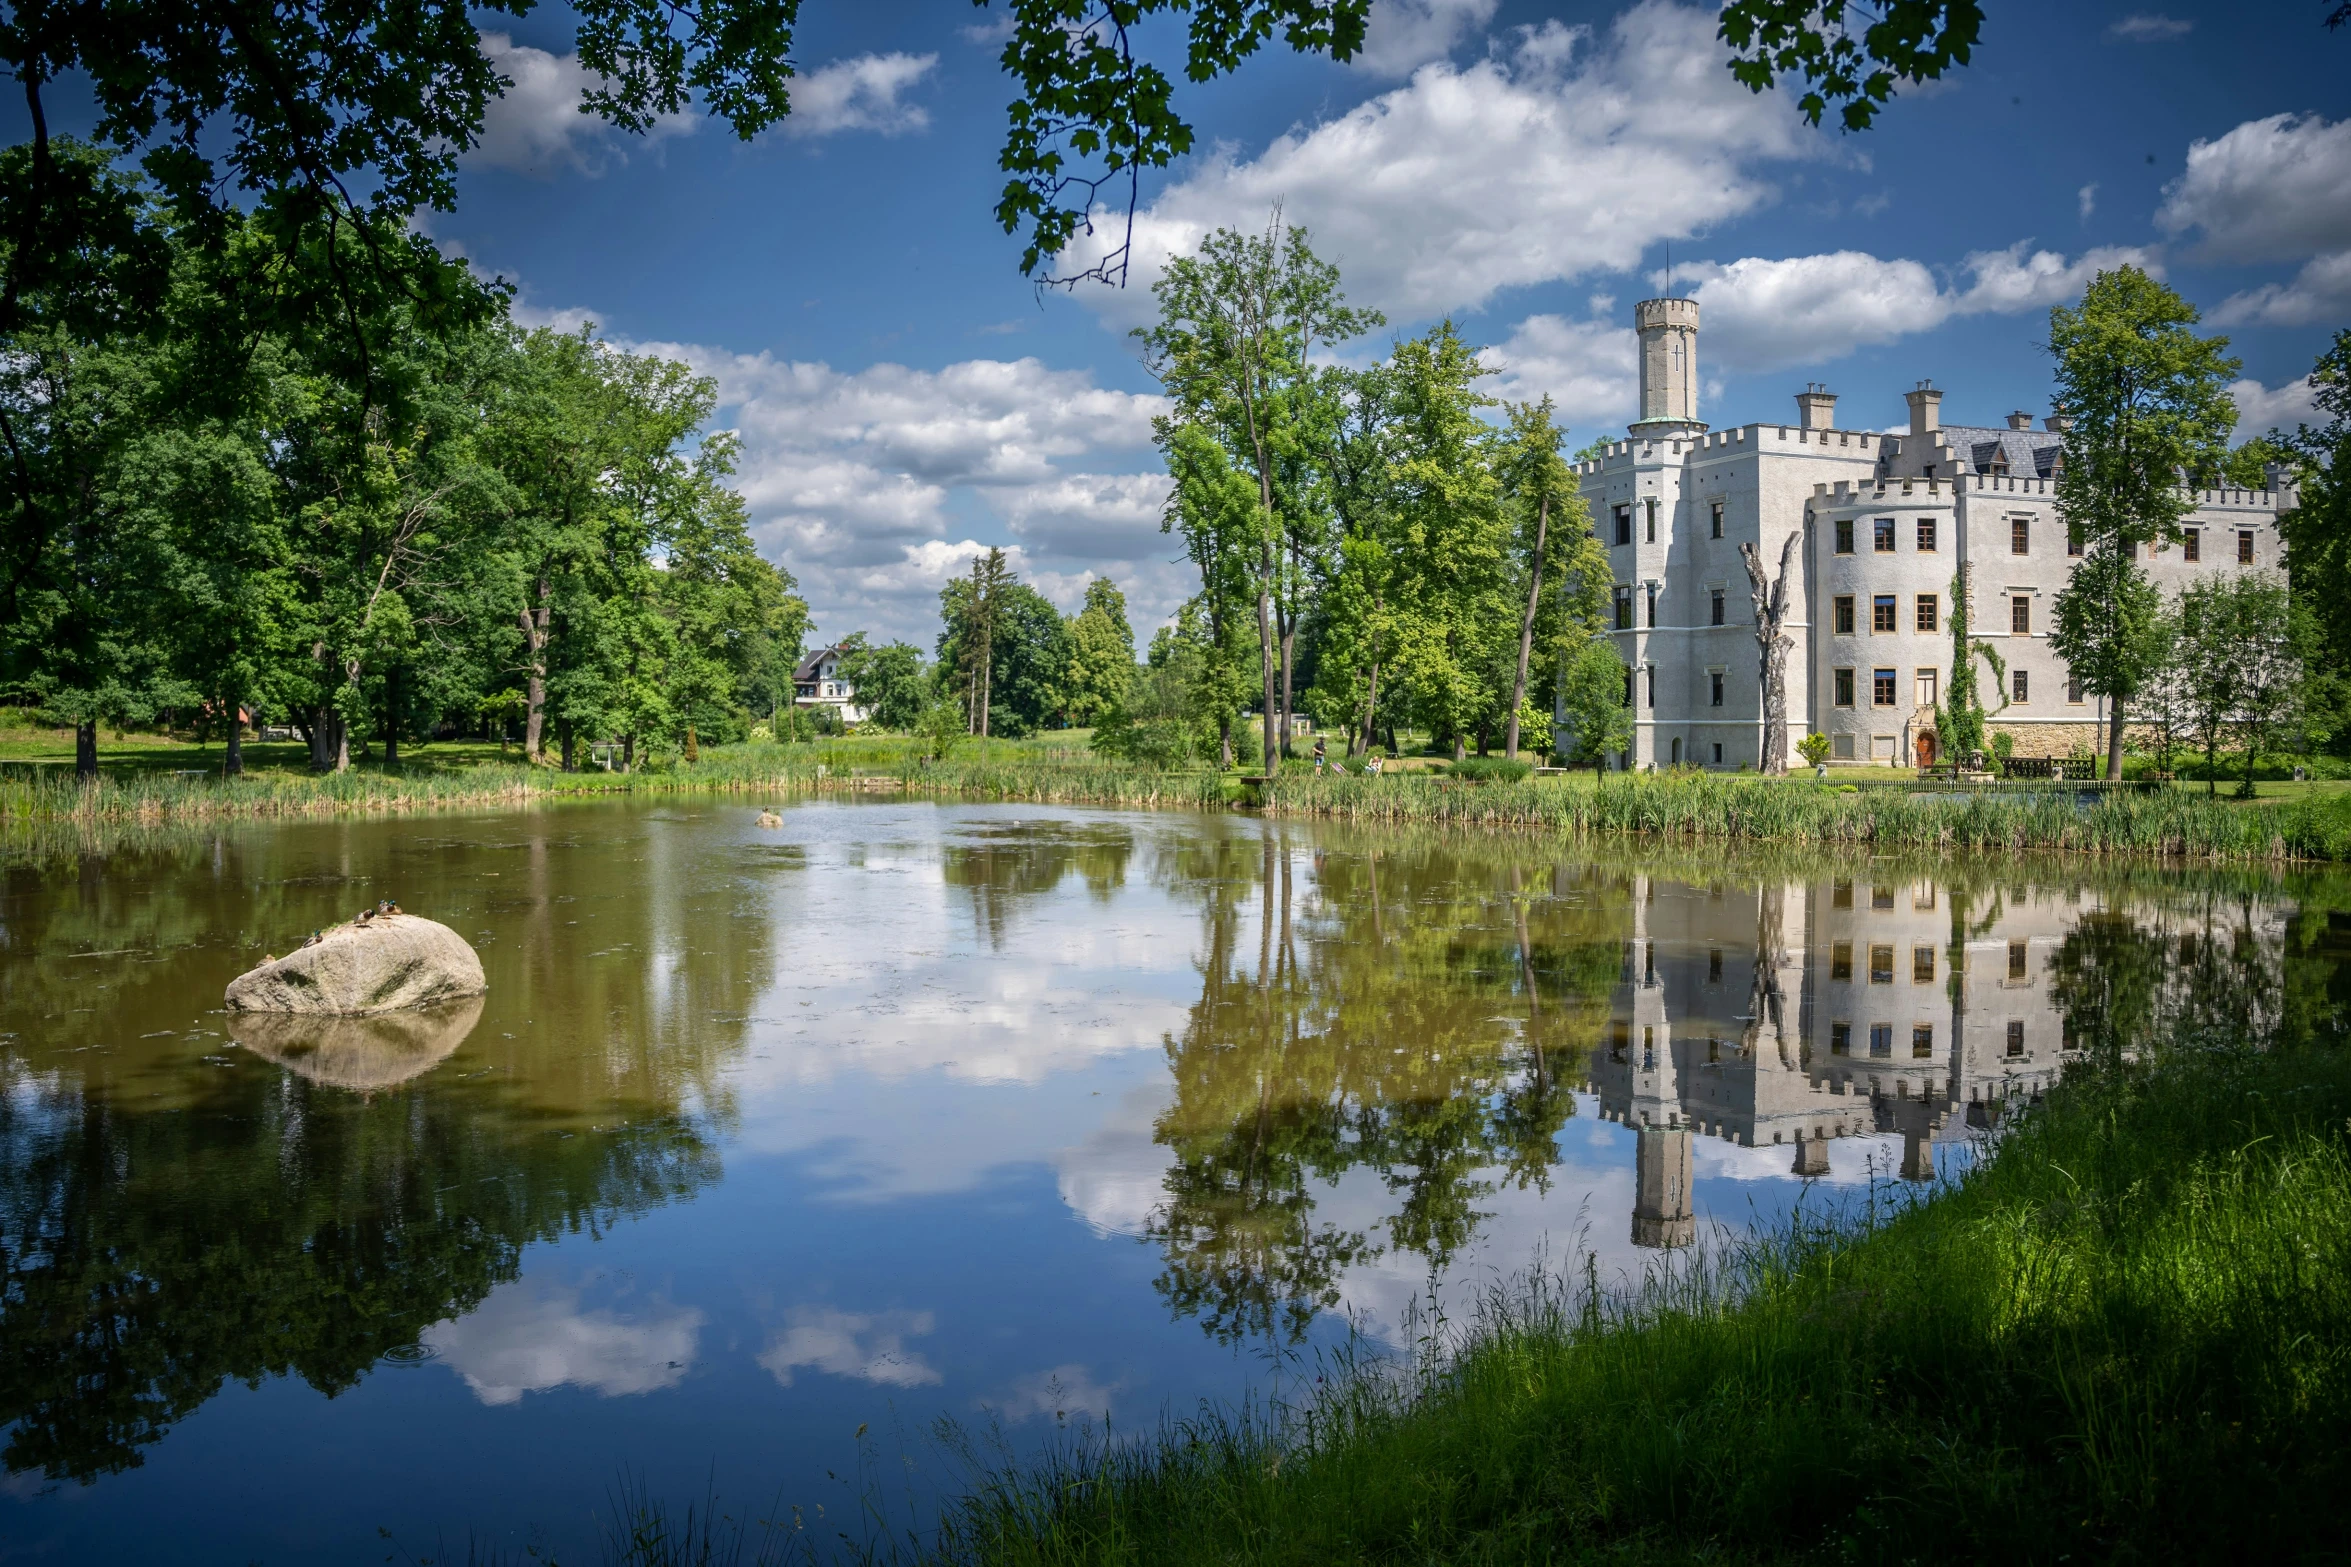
[1063,0,1827,320]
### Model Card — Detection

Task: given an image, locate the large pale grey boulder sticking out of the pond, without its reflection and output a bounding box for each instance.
[223,914,489,1017]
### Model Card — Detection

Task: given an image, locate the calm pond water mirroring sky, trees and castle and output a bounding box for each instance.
[0,801,2306,1562]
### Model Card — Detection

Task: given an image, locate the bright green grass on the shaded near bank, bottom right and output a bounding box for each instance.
[907,1048,2351,1567]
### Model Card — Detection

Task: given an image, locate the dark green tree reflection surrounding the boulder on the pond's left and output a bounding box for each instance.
[0,815,771,1482]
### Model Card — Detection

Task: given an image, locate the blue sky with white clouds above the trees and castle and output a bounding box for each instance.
[50,0,2351,646]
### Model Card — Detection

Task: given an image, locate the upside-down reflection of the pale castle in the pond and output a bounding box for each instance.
[1585,876,2193,1247]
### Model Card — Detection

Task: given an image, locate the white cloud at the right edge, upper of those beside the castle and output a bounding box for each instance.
[2156,115,2351,261]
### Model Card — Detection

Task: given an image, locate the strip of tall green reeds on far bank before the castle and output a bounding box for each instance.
[1265,773,2351,860]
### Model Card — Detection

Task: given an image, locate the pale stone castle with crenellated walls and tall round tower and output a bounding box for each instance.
[1554,298,2295,768]
